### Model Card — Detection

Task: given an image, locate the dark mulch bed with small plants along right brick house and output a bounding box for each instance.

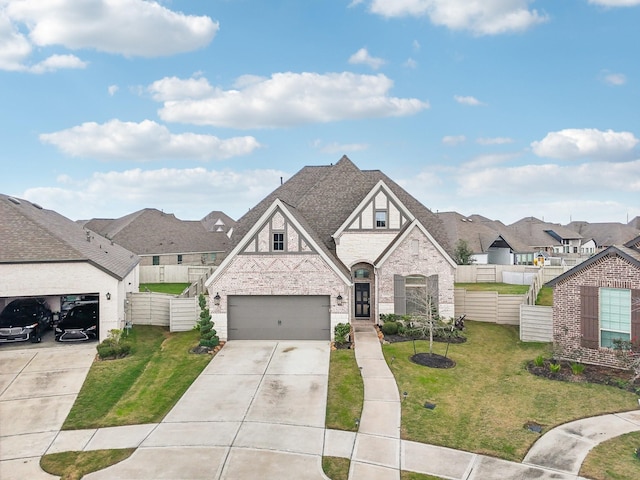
[527,360,640,393]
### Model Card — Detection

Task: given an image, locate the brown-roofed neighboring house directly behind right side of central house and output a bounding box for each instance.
[438,212,533,265]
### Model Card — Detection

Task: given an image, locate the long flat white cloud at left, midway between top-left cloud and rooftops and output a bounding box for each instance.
[40,120,260,161]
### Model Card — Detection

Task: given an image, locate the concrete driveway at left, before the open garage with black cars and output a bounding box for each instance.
[0,343,96,480]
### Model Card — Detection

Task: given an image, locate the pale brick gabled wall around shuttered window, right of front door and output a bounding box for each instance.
[376,227,455,318]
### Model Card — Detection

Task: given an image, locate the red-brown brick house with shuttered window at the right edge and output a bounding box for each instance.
[548,244,640,367]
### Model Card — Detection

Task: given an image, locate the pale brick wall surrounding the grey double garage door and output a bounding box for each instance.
[209,253,351,340]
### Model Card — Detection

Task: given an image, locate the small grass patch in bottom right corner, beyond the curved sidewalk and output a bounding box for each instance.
[580,432,640,480]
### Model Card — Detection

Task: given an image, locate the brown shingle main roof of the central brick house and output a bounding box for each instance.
[231,156,452,262]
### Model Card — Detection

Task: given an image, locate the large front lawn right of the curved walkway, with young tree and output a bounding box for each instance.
[383,322,637,461]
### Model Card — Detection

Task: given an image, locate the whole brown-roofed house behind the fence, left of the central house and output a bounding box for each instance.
[84,208,235,266]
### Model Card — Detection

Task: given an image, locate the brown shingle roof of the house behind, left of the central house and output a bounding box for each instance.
[84,208,229,255]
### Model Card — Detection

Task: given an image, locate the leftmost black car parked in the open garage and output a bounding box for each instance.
[0,298,53,343]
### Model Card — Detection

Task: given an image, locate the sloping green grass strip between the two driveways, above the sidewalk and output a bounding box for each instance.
[62,325,211,430]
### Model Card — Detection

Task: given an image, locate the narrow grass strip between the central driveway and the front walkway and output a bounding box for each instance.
[326,350,364,431]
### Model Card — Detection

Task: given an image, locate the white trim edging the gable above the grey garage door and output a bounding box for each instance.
[204,198,351,288]
